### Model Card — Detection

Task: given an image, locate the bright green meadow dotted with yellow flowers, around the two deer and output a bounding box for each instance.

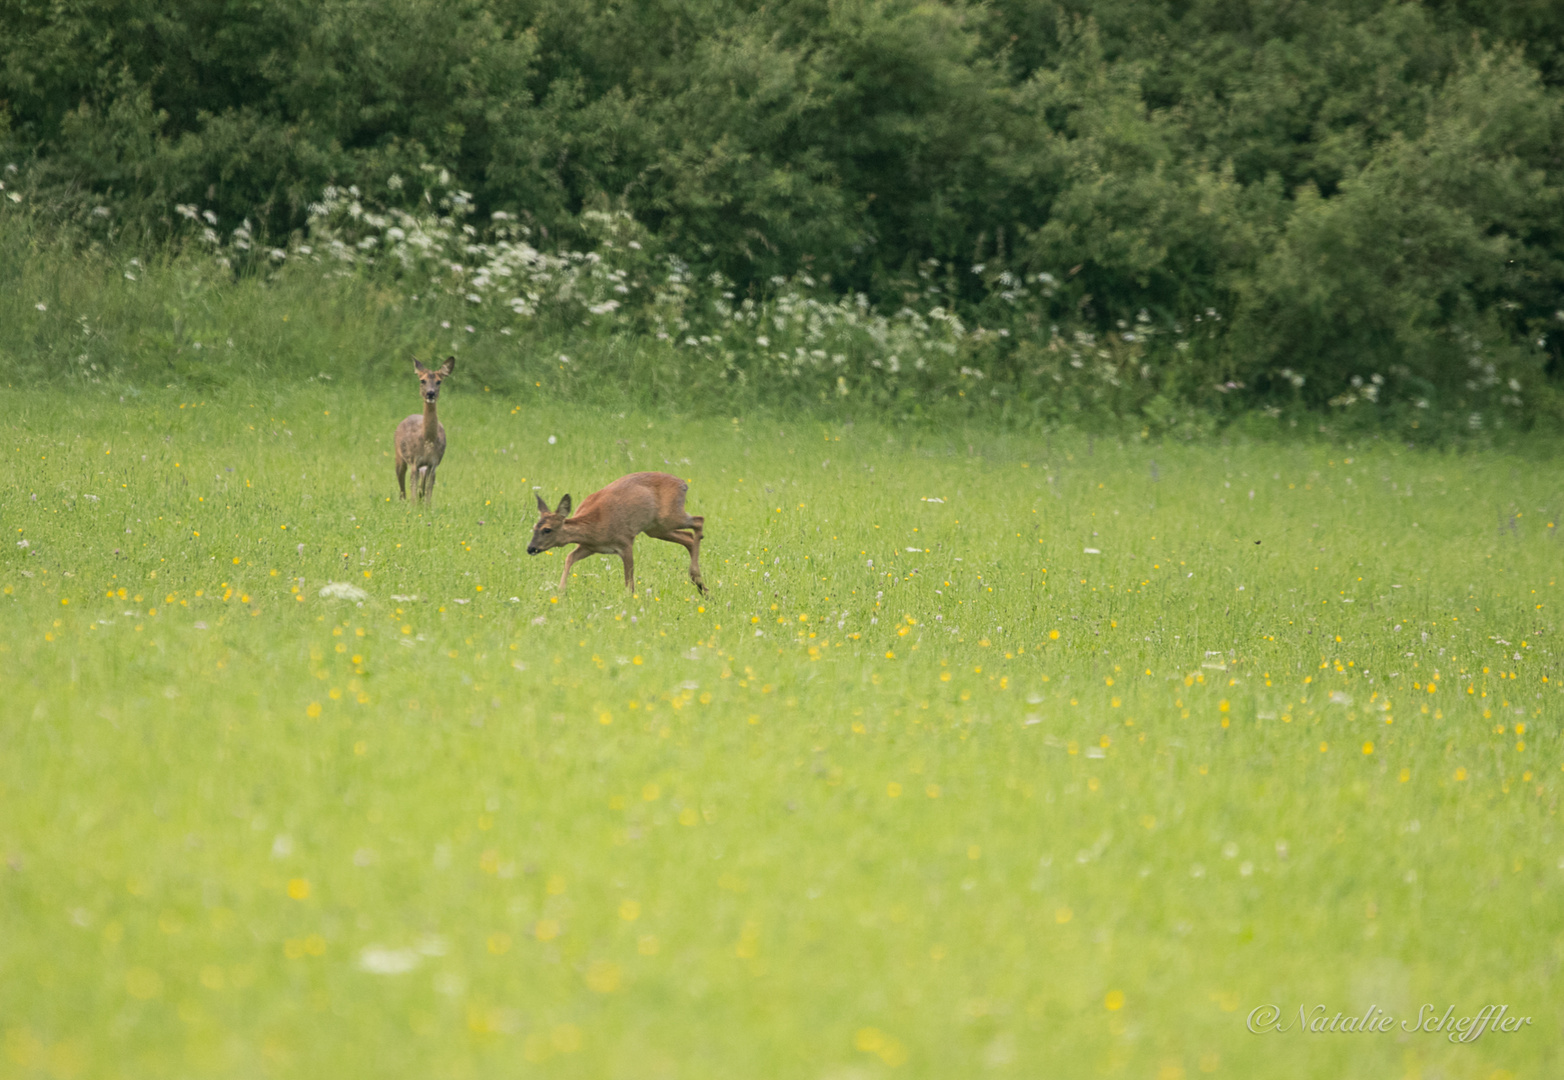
[0,384,1564,1080]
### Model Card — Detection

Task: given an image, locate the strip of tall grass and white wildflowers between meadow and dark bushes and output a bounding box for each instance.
[9,166,1561,441]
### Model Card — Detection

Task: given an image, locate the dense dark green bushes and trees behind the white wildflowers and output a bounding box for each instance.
[0,0,1564,422]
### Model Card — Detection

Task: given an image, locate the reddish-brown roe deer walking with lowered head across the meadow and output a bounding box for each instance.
[527,472,705,592]
